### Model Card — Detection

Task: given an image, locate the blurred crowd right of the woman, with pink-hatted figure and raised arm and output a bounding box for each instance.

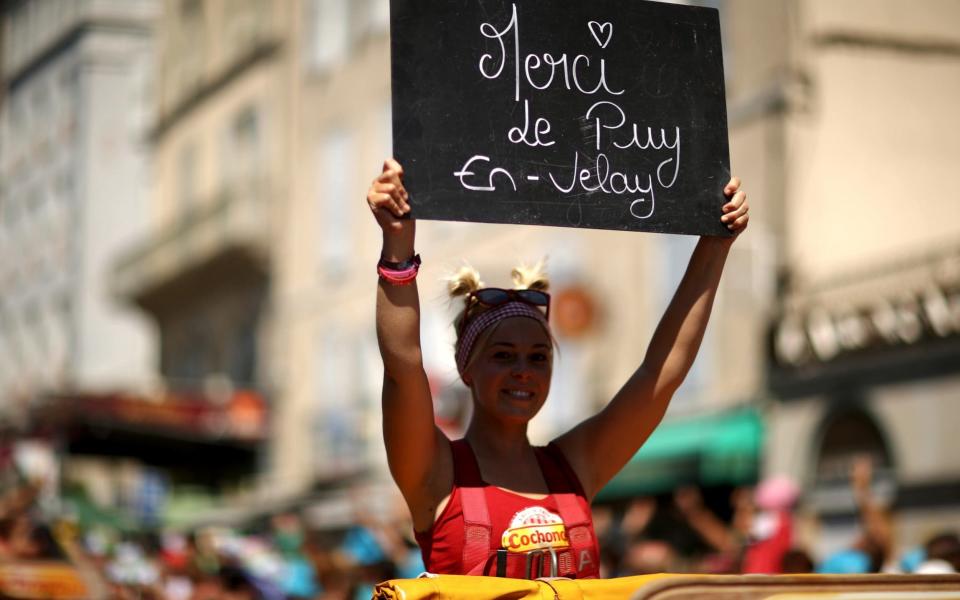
[594,457,960,577]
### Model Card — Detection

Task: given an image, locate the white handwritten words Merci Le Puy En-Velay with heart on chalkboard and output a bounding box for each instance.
[453,4,681,219]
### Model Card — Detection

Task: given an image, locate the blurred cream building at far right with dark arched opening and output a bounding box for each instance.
[724,0,960,556]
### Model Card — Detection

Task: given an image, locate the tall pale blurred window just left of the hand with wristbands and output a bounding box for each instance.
[316,129,356,277]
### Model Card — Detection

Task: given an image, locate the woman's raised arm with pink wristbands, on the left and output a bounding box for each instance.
[367,159,453,531]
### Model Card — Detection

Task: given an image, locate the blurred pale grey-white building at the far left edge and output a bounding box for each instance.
[0,0,156,504]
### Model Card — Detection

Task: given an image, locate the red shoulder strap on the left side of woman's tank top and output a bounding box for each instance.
[450,439,493,575]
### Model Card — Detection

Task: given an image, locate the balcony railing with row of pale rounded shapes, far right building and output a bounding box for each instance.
[769,241,960,395]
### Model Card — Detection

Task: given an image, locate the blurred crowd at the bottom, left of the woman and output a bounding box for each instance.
[0,484,423,600]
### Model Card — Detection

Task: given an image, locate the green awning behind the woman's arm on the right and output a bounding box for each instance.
[596,408,763,502]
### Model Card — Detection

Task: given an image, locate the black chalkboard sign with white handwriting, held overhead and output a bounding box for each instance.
[391,0,730,235]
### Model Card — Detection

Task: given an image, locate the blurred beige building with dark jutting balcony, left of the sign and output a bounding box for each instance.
[111,0,298,518]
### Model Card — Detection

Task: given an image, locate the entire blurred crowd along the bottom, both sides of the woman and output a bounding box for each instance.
[0,463,960,600]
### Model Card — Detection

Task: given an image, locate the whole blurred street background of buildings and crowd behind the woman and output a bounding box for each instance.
[0,0,960,599]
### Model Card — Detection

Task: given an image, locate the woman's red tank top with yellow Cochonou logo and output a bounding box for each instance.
[416,439,600,579]
